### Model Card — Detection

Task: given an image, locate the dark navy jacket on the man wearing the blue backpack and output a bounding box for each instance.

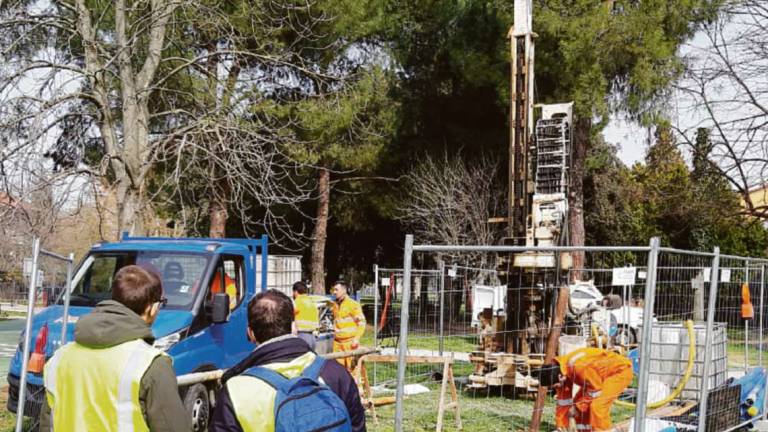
[209,337,366,432]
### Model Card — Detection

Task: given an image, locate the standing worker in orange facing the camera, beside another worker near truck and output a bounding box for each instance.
[331,282,365,371]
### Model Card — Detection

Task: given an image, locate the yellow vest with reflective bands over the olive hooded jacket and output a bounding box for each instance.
[43,339,165,432]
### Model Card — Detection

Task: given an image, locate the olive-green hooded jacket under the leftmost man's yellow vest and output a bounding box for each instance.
[40,300,192,432]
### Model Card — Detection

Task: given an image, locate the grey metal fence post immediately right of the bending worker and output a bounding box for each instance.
[634,237,660,432]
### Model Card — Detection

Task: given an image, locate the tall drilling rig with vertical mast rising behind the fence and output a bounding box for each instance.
[504,0,573,355]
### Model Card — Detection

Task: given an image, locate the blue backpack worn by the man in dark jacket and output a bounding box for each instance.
[245,356,352,432]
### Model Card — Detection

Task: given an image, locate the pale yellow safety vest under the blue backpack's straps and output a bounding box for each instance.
[226,352,322,432]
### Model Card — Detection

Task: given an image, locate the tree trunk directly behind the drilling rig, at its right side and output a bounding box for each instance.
[568,117,592,281]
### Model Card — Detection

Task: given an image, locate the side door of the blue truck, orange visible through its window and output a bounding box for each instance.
[206,255,254,367]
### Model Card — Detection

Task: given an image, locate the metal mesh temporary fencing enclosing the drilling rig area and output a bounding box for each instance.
[380,240,768,432]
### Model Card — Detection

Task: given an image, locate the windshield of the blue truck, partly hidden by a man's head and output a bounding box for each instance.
[58,251,210,309]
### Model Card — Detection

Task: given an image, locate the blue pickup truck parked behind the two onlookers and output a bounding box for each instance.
[8,235,268,430]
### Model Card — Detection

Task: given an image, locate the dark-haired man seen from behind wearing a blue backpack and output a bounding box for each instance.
[209,290,366,432]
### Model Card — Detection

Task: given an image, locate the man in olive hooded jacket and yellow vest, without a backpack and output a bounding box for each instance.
[40,265,192,432]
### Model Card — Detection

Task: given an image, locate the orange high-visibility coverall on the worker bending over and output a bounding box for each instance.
[555,348,632,431]
